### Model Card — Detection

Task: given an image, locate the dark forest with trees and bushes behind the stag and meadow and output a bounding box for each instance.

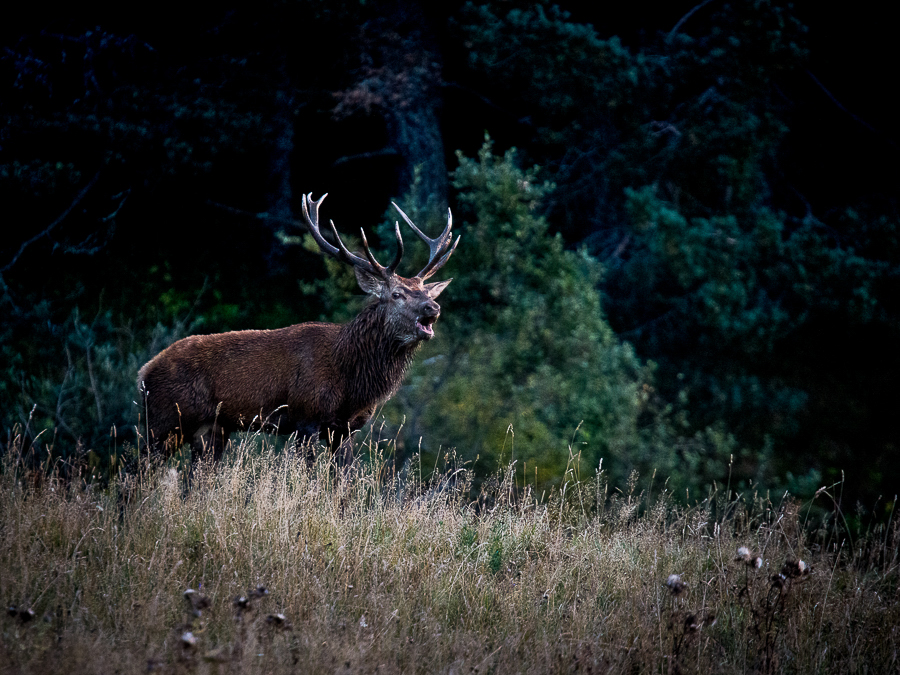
[0,0,900,504]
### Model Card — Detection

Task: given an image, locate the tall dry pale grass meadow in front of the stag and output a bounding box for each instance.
[0,439,900,675]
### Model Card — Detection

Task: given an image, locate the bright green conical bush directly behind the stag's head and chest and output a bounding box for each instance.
[372,141,735,489]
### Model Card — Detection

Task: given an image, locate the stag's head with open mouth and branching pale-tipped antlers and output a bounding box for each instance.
[303,193,460,344]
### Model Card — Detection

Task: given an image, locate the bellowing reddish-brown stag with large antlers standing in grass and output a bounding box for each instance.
[138,194,459,460]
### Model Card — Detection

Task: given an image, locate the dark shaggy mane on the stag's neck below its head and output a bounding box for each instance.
[335,302,419,405]
